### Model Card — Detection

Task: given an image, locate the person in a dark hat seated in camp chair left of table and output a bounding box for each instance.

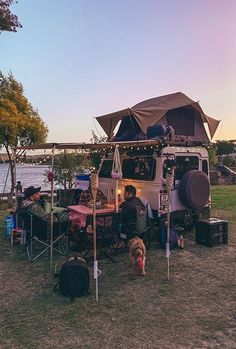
[18,186,69,237]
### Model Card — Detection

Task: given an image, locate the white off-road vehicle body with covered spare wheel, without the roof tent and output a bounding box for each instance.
[99,142,210,228]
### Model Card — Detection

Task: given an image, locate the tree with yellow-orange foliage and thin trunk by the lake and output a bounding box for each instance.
[0,71,48,198]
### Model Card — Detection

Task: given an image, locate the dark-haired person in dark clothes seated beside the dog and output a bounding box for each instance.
[120,185,145,240]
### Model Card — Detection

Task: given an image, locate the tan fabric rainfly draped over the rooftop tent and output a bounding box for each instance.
[96,92,219,139]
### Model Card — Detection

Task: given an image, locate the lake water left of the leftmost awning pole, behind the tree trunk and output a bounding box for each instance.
[0,163,50,193]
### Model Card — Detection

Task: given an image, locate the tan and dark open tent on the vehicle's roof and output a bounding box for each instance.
[96,92,219,143]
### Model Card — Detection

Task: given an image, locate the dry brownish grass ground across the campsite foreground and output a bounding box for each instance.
[0,186,236,349]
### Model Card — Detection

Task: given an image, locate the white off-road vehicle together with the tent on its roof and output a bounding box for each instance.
[96,92,219,226]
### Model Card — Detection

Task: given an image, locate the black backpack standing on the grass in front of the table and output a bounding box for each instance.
[54,257,90,300]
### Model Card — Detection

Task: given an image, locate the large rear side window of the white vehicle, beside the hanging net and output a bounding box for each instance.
[122,158,156,181]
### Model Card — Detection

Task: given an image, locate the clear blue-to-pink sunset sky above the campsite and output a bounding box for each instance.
[0,0,236,142]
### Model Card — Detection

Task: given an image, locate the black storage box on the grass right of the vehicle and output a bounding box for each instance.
[196,218,228,247]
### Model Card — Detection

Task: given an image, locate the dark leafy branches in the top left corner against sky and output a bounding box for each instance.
[0,0,22,33]
